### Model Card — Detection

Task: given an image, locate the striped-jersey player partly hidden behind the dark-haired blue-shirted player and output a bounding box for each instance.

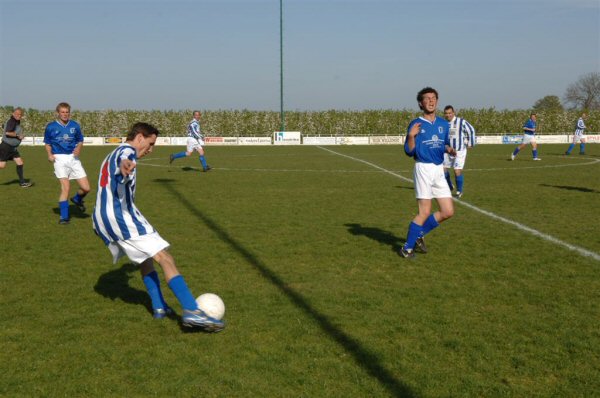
[444,105,475,198]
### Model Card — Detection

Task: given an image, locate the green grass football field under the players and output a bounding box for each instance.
[0,145,600,397]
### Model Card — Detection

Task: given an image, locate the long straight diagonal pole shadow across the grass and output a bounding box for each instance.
[154,179,416,397]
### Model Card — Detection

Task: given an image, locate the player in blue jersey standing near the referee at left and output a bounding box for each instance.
[44,102,90,224]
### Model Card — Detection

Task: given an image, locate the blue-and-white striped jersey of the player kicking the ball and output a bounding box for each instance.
[92,143,155,245]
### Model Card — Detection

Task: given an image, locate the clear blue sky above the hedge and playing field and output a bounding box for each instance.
[0,0,600,110]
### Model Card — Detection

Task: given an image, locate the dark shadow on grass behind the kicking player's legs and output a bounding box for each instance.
[94,263,152,313]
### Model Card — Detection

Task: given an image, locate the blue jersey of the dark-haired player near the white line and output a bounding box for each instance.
[404,116,450,165]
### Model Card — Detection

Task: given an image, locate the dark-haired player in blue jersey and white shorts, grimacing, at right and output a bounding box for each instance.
[399,87,456,258]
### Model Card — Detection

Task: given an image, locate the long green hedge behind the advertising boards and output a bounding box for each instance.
[0,106,600,137]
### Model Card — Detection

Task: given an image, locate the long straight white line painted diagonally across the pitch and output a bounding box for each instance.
[318,146,600,261]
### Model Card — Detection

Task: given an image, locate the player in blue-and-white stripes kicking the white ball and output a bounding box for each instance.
[92,123,225,332]
